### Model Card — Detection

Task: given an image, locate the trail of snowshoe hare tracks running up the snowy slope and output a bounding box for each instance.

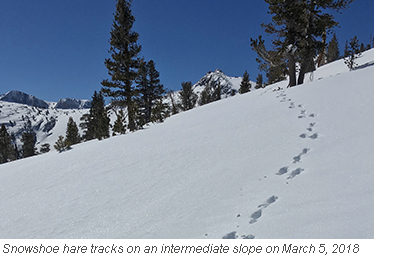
[222,91,318,239]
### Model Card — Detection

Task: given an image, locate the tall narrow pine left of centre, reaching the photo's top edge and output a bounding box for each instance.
[101,0,141,131]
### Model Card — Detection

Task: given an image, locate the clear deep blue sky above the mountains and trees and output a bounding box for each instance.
[0,0,374,101]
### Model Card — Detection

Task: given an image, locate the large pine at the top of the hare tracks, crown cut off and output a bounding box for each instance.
[251,0,354,87]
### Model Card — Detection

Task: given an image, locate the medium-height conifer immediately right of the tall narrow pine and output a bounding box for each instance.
[136,60,165,124]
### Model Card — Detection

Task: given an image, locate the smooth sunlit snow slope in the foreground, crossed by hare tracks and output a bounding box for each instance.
[0,50,374,238]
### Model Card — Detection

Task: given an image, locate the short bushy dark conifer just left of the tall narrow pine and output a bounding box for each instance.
[80,91,110,140]
